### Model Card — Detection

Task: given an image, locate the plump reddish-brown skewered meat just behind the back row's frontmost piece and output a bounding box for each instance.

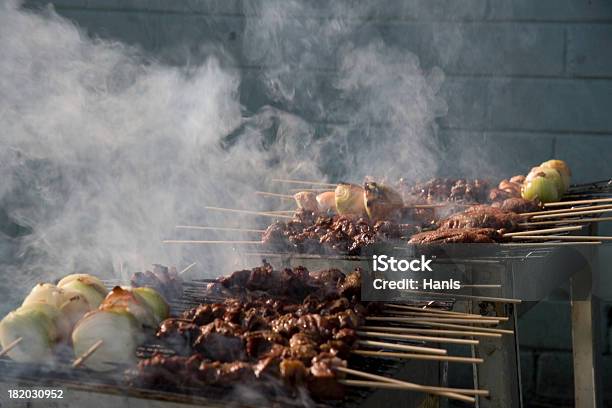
[440,205,523,232]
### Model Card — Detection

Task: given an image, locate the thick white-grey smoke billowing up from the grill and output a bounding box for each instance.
[0,1,446,310]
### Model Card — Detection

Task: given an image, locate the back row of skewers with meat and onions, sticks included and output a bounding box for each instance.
[165,160,612,250]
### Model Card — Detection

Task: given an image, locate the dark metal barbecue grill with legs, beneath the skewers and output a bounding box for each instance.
[0,181,612,408]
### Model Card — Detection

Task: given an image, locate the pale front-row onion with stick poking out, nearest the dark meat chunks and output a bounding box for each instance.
[72,309,143,371]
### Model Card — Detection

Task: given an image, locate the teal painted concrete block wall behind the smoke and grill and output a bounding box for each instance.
[14,0,612,406]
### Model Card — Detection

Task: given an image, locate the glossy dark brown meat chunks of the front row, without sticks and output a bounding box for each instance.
[128,263,375,399]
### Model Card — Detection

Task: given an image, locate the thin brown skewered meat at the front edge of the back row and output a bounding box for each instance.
[408,228,503,244]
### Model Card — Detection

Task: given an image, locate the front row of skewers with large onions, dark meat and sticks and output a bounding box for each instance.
[0,264,512,402]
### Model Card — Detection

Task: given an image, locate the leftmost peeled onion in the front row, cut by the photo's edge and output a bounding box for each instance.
[0,302,70,363]
